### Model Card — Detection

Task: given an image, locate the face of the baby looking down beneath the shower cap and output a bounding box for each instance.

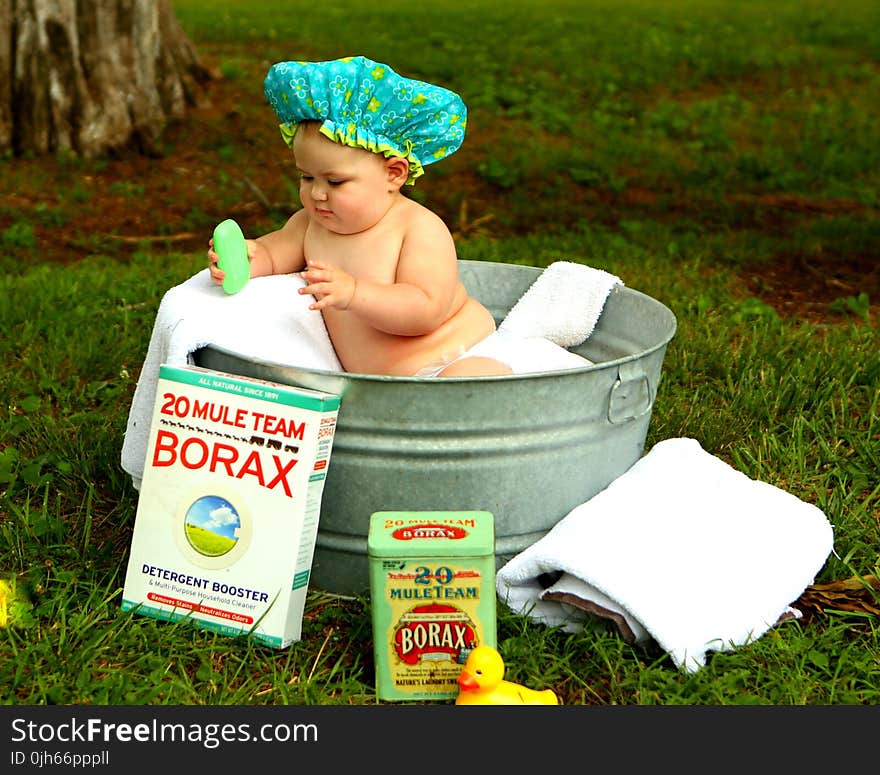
[293,124,397,234]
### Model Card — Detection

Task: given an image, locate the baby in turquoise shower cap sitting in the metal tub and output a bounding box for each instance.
[208,57,512,377]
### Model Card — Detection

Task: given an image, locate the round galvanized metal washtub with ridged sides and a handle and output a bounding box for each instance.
[194,261,676,594]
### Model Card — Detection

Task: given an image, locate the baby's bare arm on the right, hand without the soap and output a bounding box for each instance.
[300,211,458,336]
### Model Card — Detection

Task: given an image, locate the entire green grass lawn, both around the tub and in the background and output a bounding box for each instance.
[0,0,880,705]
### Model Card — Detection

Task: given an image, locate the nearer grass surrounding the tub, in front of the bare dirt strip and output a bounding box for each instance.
[0,230,880,704]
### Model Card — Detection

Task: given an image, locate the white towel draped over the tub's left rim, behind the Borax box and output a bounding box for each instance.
[122,269,342,489]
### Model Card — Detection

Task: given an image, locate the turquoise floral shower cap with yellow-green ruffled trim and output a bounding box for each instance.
[263,56,467,184]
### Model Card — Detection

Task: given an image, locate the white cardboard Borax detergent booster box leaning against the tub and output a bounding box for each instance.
[122,364,340,648]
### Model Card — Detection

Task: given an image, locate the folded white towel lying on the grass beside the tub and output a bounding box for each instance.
[497,438,833,672]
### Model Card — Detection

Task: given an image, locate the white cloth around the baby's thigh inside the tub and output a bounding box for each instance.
[414,331,593,377]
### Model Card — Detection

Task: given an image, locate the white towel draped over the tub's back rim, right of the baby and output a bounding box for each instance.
[498,261,623,347]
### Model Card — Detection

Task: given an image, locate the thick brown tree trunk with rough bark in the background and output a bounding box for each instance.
[0,0,211,158]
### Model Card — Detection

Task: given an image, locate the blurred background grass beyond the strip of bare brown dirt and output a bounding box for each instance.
[175,0,880,205]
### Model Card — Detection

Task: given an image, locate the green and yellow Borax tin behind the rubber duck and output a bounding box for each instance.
[367,511,496,700]
